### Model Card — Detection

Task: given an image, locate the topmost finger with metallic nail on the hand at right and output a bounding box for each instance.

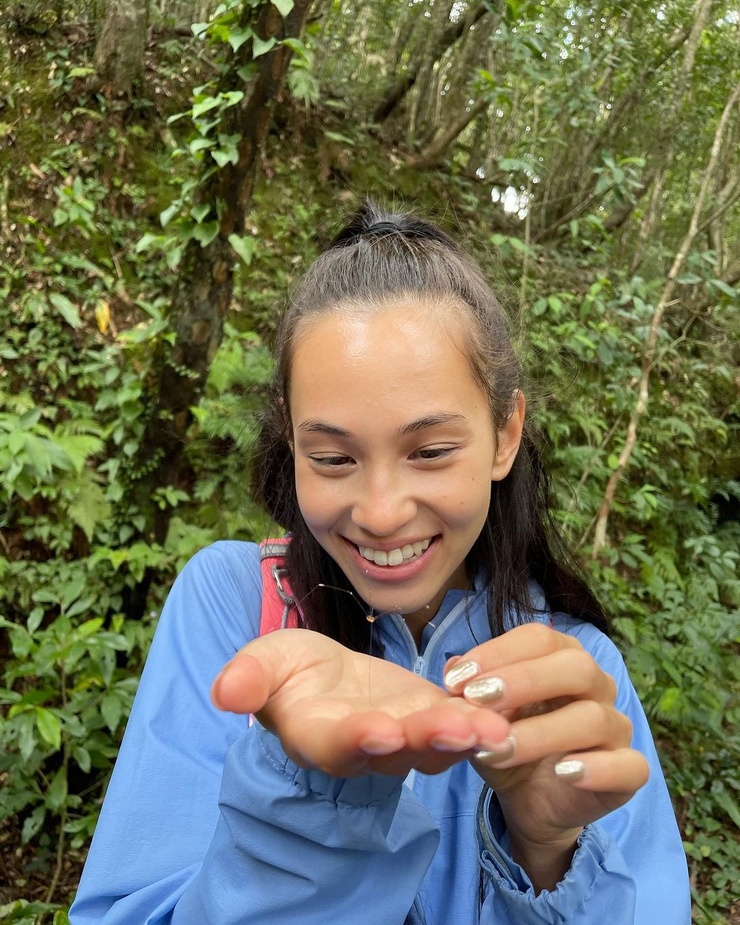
[444,623,582,693]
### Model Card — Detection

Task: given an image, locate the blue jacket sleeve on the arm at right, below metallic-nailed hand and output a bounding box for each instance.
[478,615,691,925]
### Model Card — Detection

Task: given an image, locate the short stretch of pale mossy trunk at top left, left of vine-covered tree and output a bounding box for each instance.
[93,0,147,96]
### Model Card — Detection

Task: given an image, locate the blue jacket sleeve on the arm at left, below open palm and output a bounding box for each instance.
[70,542,438,925]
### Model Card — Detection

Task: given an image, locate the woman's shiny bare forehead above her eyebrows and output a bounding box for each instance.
[289,300,486,423]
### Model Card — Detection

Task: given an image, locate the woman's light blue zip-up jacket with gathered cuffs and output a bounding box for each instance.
[70,542,690,925]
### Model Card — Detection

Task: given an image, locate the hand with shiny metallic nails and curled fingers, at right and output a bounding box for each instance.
[445,623,648,891]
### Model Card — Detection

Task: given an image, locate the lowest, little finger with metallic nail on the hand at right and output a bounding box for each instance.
[555,748,650,811]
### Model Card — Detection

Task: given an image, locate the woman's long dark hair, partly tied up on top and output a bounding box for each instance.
[252,202,607,652]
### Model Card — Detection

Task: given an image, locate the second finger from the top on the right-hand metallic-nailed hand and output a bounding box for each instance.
[462,648,617,711]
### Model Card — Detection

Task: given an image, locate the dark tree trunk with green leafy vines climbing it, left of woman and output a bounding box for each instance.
[140,0,312,542]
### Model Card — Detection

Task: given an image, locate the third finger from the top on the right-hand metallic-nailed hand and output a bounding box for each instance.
[476,700,632,769]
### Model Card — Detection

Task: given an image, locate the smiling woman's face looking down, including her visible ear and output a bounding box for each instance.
[290,300,524,635]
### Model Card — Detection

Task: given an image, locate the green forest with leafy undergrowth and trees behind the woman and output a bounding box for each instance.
[0,0,740,925]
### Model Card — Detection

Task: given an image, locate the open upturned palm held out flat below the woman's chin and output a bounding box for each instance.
[211,629,509,777]
